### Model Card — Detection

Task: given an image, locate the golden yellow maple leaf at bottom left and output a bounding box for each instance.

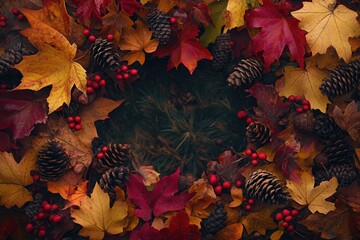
[70,184,138,240]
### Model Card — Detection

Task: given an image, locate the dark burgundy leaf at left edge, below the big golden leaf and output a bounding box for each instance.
[0,90,47,139]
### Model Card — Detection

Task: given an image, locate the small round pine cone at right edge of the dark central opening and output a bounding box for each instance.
[246,122,271,147]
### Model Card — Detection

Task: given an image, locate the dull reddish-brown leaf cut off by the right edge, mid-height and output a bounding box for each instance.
[333,101,360,141]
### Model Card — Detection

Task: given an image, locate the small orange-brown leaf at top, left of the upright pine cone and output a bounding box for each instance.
[119,20,159,65]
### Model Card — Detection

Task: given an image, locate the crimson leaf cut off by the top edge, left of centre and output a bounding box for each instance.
[74,0,110,22]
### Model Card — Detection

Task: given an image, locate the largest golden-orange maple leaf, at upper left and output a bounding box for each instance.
[15,9,86,113]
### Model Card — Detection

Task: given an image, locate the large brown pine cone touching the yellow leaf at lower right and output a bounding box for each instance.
[245,169,290,204]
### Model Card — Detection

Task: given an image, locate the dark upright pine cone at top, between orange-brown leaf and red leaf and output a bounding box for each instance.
[147,8,171,45]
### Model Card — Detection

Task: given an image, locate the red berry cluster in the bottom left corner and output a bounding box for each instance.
[25,201,63,238]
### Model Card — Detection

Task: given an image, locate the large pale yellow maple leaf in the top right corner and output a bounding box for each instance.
[291,0,360,62]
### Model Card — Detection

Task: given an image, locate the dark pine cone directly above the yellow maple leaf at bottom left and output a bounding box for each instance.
[100,166,129,199]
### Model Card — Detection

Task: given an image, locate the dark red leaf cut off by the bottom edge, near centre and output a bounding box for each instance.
[159,210,200,240]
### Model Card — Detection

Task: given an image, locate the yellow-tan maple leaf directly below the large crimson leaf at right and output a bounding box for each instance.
[275,59,329,112]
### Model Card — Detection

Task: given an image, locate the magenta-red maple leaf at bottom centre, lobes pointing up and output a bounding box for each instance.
[127,168,193,221]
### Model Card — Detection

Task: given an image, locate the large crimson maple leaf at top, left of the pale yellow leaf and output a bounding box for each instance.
[246,0,306,71]
